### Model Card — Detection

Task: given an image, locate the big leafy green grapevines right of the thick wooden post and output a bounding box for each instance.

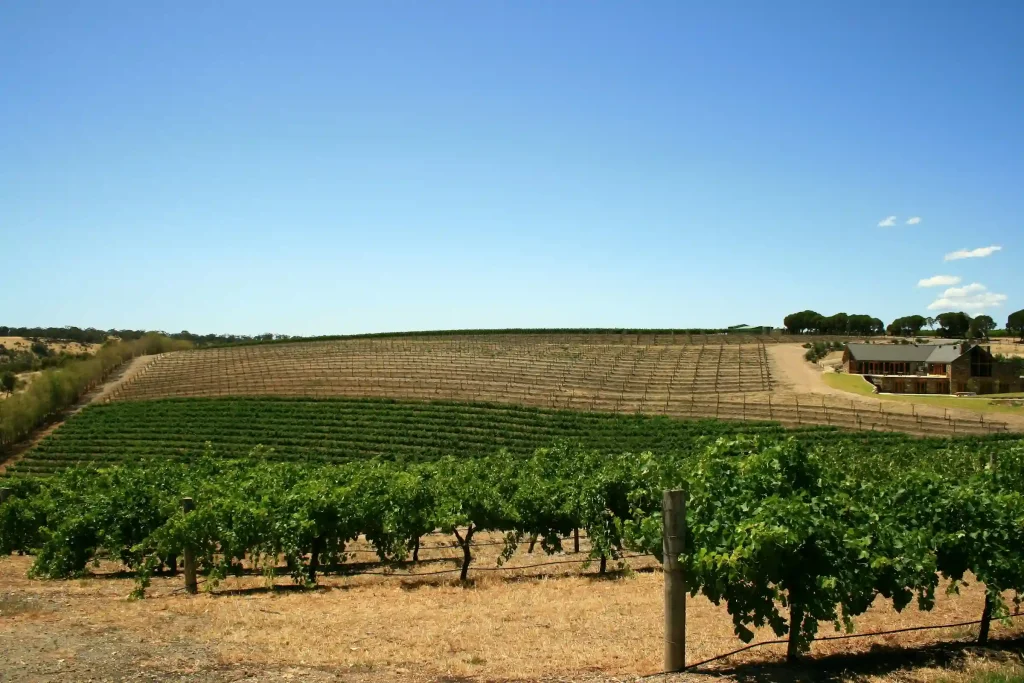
[624,440,1024,658]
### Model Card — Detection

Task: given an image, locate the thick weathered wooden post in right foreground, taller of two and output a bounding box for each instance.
[662,489,686,672]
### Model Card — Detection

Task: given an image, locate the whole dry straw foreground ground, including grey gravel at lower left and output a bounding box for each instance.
[0,532,1024,681]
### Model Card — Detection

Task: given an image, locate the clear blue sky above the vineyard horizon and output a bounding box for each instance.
[0,1,1024,334]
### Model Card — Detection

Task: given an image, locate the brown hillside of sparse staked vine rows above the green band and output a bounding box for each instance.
[99,335,1008,436]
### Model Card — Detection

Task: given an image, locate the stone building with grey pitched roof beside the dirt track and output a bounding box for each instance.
[843,341,1024,394]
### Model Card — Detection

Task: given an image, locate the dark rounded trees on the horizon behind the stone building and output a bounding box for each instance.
[782,309,1024,341]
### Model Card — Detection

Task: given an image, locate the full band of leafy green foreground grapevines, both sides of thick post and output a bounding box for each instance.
[0,433,1024,654]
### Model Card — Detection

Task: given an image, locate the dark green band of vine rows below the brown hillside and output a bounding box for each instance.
[7,397,1019,476]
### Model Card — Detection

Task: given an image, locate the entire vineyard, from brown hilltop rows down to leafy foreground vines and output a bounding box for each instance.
[0,335,1024,671]
